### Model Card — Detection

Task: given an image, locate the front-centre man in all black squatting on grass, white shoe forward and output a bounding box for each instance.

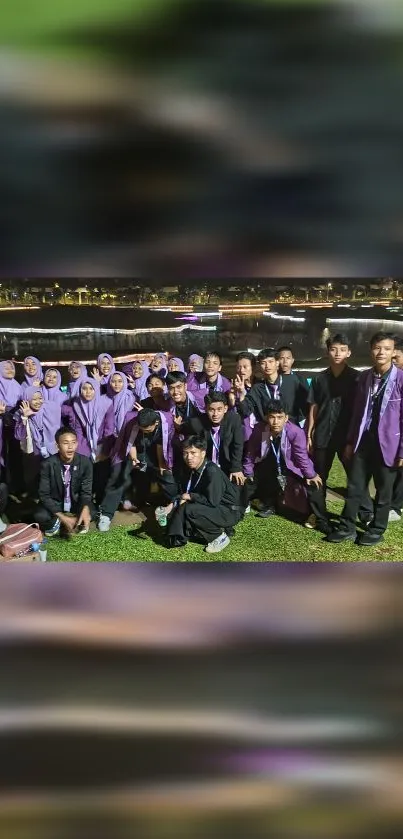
[159,434,242,553]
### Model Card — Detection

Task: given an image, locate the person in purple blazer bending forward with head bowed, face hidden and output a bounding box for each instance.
[98,408,177,532]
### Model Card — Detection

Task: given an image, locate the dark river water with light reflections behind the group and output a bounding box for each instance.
[0,306,403,373]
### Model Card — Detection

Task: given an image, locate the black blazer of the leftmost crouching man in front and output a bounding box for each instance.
[39,454,93,515]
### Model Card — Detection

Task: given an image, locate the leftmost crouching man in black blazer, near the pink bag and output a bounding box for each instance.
[35,428,95,536]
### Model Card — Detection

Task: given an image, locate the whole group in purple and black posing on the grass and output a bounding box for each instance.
[0,332,403,553]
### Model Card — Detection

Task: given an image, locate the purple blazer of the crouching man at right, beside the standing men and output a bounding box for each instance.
[243,421,316,478]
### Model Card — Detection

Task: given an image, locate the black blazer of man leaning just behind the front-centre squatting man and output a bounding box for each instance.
[189,411,244,477]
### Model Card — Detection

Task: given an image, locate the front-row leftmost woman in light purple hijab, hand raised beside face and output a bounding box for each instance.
[14,387,61,496]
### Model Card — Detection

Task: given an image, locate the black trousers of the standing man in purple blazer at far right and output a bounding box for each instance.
[340,432,398,534]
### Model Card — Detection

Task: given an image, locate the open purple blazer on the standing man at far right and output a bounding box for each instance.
[347,367,403,466]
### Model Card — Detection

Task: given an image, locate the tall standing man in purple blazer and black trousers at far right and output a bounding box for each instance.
[328,332,403,546]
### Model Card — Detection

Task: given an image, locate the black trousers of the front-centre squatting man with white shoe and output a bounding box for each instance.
[167,501,241,543]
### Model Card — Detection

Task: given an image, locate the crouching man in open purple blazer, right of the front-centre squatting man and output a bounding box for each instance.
[243,400,331,534]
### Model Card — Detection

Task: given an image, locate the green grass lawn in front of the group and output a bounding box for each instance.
[48,461,403,562]
